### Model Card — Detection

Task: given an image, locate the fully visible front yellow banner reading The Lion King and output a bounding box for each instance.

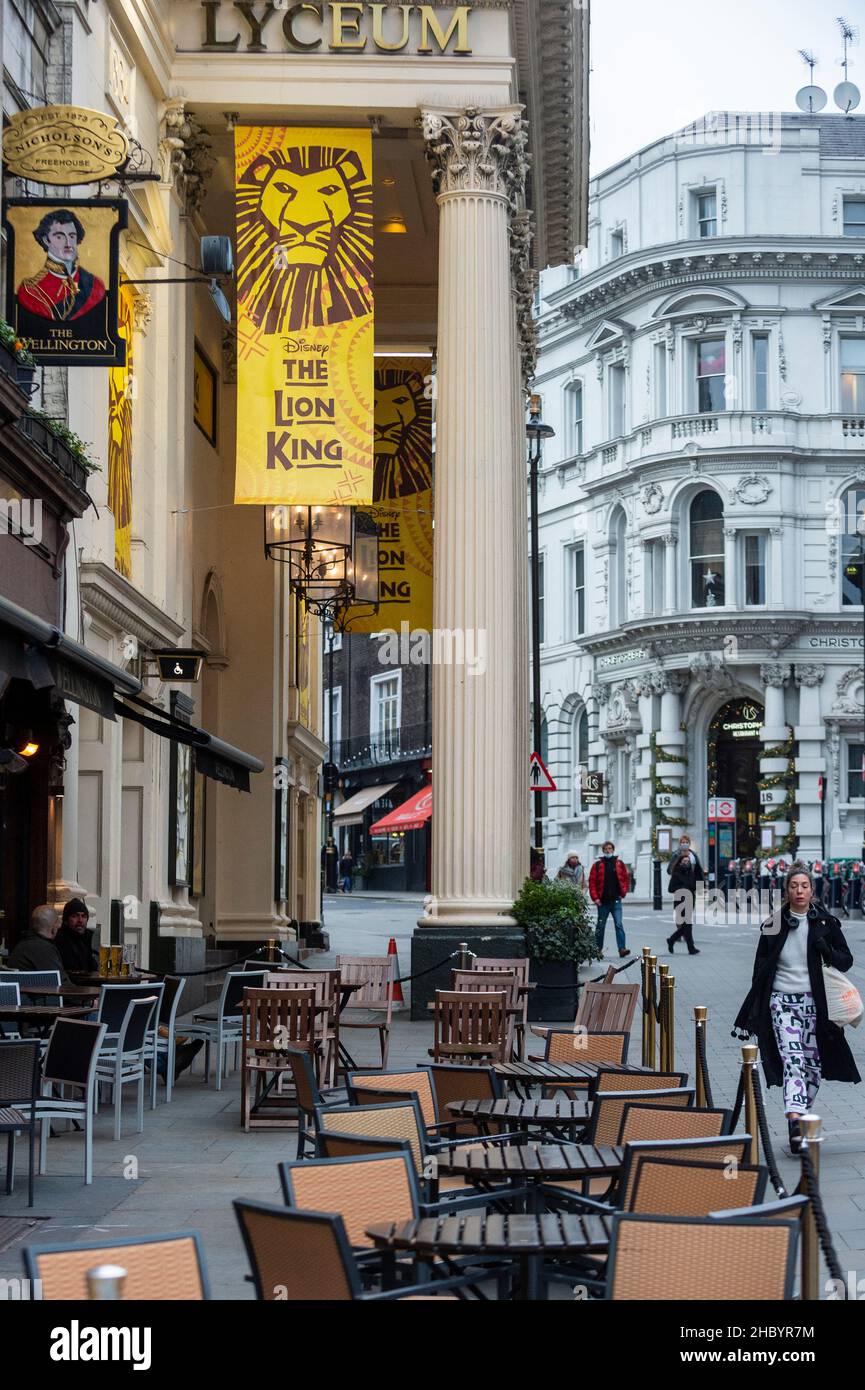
[235,126,373,506]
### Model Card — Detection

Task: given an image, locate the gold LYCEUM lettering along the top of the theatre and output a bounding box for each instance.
[200,0,473,54]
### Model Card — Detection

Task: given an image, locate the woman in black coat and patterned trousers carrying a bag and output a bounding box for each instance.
[734,863,861,1154]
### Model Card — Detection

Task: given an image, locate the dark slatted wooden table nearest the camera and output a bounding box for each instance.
[367,1212,612,1301]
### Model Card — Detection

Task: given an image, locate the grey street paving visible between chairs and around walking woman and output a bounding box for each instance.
[0,894,865,1300]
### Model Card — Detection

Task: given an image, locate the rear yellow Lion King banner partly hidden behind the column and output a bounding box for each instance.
[345,357,433,632]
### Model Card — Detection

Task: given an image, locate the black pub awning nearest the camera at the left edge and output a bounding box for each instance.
[0,598,142,719]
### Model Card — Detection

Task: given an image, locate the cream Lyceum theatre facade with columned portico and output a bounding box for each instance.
[3,0,587,967]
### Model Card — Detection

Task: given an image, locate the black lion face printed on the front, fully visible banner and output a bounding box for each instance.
[238,145,373,334]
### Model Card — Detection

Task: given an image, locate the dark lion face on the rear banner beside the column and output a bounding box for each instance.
[373,367,433,502]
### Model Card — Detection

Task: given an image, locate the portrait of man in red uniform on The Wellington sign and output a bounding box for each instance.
[15,207,106,324]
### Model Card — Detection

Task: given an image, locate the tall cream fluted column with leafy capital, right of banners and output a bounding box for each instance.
[423,107,528,927]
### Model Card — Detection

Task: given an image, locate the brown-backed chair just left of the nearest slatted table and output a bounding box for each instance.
[234,1201,469,1302]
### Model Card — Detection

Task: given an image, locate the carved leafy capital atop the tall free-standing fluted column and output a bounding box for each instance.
[420,106,528,213]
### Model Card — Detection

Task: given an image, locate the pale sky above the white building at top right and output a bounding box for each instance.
[588,0,865,175]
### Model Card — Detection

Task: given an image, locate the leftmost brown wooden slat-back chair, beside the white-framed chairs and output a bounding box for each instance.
[241,988,317,1130]
